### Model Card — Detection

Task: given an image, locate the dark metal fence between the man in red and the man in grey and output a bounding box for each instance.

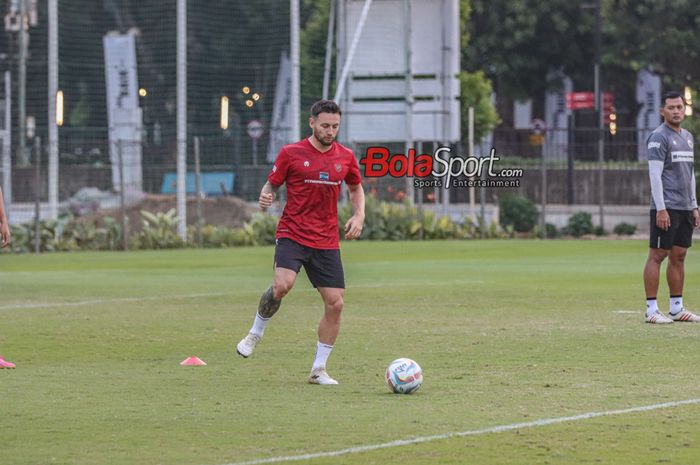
[355,128,649,206]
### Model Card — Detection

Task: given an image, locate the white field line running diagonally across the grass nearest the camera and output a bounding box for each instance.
[226,398,700,465]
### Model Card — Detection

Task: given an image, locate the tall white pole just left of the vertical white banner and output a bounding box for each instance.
[47,0,58,220]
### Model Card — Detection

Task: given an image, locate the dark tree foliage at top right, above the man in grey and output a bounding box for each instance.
[463,0,700,125]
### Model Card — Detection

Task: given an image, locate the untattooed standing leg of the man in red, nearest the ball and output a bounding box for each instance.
[309,287,345,384]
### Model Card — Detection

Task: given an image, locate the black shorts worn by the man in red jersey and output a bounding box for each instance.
[275,237,345,289]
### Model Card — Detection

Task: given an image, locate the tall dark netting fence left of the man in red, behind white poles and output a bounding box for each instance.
[0,0,290,210]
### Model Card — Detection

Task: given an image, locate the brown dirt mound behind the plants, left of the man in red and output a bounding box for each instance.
[80,195,260,232]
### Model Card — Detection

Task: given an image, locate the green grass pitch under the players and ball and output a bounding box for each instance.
[0,241,700,465]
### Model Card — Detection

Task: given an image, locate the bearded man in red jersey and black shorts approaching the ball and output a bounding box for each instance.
[236,100,365,385]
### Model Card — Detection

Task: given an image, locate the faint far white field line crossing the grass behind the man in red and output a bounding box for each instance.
[0,279,483,311]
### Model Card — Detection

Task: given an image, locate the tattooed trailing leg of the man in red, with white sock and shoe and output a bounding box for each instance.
[236,267,297,358]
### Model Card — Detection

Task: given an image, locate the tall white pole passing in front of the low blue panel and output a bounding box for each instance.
[177,0,187,241]
